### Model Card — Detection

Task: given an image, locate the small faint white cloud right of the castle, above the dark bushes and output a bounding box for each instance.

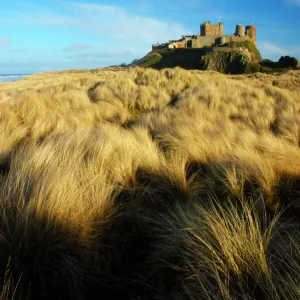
[258,41,300,59]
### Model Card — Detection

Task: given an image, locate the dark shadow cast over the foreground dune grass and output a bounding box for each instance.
[0,162,299,300]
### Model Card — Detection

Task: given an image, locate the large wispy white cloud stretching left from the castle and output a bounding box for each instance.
[22,2,190,48]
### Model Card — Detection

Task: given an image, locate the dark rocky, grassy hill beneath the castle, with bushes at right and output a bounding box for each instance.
[131,41,297,74]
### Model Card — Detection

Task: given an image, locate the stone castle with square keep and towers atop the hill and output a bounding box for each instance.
[152,22,256,50]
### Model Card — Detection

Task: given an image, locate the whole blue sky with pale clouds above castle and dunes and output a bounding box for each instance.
[0,0,300,74]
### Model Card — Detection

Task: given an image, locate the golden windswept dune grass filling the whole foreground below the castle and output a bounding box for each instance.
[0,67,300,300]
